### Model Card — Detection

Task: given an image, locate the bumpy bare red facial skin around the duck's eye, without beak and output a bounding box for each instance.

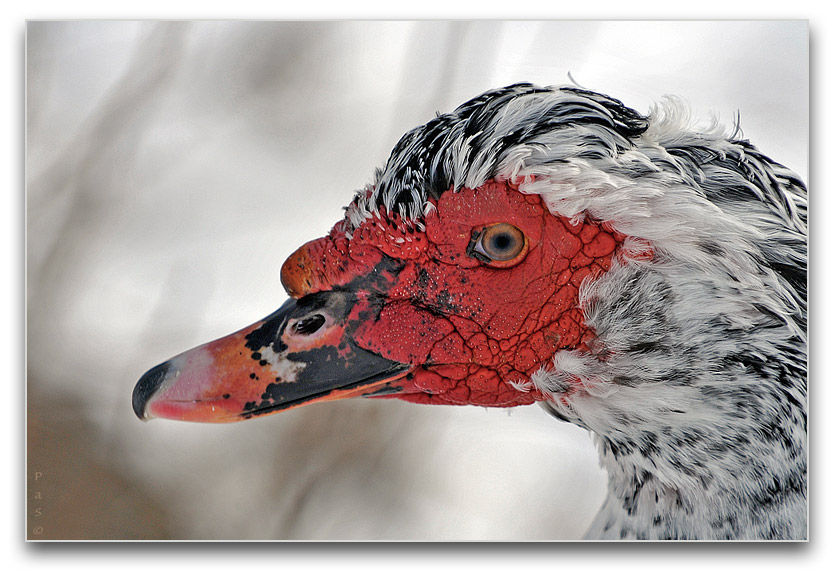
[281,181,624,407]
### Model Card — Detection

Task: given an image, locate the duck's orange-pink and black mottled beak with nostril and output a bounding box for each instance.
[133,291,411,422]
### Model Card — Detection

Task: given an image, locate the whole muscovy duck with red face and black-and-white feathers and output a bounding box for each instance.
[133,83,807,539]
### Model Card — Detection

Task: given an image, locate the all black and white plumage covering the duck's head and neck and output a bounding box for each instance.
[347,84,807,539]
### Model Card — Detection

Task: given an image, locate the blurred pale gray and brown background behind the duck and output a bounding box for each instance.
[26,21,809,540]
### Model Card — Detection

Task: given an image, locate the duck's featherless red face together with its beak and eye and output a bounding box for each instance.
[133,172,623,422]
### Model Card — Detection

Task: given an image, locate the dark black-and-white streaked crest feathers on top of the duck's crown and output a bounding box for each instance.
[349,83,648,226]
